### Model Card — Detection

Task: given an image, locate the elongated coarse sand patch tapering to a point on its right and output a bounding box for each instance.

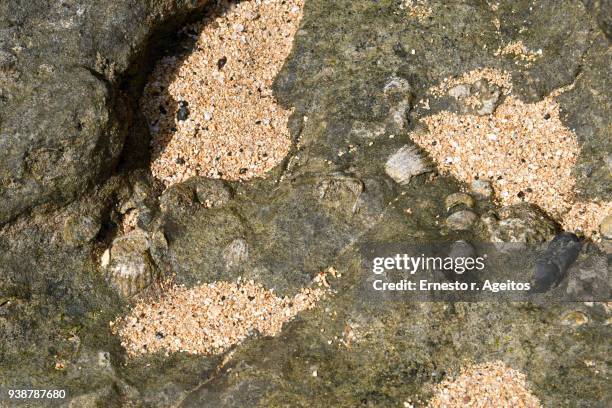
[111,268,335,357]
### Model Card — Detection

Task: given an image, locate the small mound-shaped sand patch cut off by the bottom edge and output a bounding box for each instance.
[427,361,542,408]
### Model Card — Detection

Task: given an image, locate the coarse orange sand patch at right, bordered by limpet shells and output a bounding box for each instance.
[411,68,612,240]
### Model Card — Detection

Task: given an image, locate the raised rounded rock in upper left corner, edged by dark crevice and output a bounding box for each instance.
[0,0,213,224]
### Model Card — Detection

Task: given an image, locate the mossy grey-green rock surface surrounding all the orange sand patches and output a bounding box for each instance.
[0,0,612,407]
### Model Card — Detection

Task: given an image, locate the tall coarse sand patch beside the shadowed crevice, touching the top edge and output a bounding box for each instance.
[141,0,304,186]
